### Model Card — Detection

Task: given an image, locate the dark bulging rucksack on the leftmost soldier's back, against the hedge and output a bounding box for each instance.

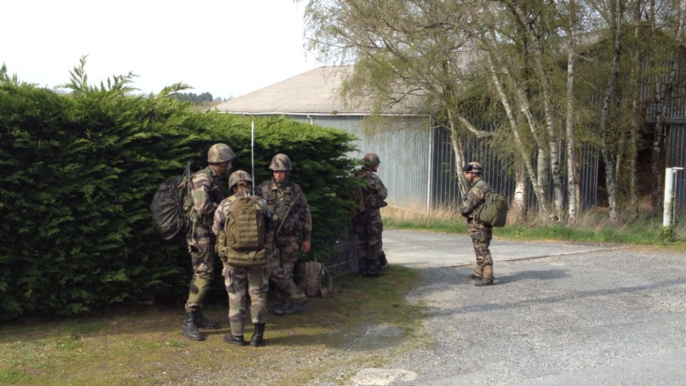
[150,162,193,240]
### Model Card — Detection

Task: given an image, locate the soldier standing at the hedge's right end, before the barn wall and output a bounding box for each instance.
[353,153,388,277]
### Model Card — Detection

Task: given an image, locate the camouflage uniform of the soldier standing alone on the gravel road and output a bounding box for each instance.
[460,179,493,278]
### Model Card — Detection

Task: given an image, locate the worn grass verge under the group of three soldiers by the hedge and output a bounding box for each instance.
[0,266,421,385]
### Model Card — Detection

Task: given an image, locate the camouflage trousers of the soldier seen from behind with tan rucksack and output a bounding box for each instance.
[222,262,269,335]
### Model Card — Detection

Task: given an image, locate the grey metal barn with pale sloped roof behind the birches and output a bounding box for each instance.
[216,66,598,211]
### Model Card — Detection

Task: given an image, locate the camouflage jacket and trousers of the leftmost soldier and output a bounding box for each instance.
[186,166,224,312]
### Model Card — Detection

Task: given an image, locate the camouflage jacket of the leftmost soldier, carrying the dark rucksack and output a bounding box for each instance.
[189,166,224,228]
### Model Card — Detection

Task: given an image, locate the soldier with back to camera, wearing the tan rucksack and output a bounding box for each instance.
[212,170,275,346]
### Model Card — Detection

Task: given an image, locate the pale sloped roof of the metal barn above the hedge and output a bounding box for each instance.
[213,66,428,115]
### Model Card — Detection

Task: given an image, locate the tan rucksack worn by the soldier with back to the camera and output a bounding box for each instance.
[223,196,269,267]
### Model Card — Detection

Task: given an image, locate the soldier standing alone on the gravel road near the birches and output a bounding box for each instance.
[460,162,493,287]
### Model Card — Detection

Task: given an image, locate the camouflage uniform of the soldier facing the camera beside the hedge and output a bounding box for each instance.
[257,178,312,304]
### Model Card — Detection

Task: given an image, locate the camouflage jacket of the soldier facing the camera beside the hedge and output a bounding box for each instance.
[257,179,312,241]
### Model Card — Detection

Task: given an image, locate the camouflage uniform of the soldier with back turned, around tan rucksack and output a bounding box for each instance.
[212,194,274,336]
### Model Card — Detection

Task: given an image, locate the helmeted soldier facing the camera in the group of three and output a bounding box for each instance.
[257,154,312,315]
